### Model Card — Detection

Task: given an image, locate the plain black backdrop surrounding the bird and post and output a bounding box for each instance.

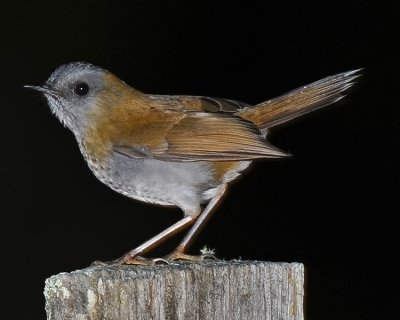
[0,0,400,320]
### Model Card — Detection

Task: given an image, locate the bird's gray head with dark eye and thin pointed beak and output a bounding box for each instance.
[25,62,108,136]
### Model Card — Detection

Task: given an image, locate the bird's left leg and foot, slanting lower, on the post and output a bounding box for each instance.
[114,213,199,265]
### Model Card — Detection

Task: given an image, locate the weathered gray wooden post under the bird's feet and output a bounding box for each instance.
[44,261,304,320]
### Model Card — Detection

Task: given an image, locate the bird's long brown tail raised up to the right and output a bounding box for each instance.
[239,69,362,130]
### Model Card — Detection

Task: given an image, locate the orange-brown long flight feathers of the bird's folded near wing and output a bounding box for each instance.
[159,113,287,160]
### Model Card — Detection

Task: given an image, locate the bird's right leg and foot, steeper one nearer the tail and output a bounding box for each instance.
[164,184,226,261]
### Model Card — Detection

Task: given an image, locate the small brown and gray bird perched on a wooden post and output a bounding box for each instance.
[25,62,361,264]
